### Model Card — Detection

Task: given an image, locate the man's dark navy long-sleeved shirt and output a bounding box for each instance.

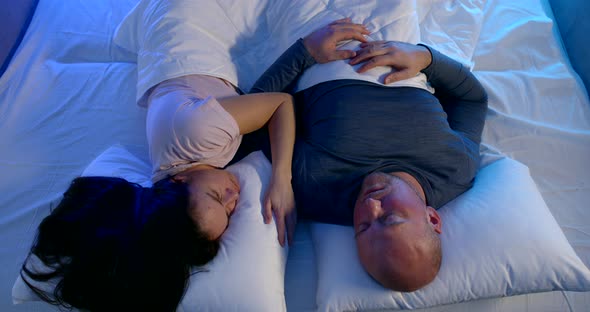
[247,41,487,225]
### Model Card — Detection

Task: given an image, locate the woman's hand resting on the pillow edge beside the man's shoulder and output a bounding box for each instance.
[264,175,297,246]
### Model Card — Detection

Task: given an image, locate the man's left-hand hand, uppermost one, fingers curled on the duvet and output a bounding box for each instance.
[303,17,371,64]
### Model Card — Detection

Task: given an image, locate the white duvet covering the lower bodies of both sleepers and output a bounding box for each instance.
[113,0,483,105]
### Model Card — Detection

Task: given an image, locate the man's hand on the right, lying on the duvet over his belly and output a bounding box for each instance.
[349,41,432,84]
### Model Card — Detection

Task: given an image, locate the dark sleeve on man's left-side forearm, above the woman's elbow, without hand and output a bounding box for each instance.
[250,39,316,93]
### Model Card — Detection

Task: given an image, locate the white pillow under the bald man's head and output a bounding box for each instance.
[311,158,590,311]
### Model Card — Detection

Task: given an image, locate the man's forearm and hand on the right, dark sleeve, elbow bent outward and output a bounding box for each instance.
[350,41,488,144]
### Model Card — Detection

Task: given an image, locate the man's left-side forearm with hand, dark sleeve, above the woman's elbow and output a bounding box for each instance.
[250,18,369,93]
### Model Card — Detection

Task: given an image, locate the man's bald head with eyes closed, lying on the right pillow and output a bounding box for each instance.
[354,172,441,288]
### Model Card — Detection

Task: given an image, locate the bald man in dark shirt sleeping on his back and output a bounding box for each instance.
[247,21,487,292]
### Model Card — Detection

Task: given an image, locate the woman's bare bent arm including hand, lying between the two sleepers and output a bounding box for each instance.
[219,93,297,246]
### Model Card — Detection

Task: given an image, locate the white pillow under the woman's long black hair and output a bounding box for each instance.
[12,145,288,311]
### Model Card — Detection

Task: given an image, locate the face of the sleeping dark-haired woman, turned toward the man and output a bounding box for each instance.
[174,166,240,239]
